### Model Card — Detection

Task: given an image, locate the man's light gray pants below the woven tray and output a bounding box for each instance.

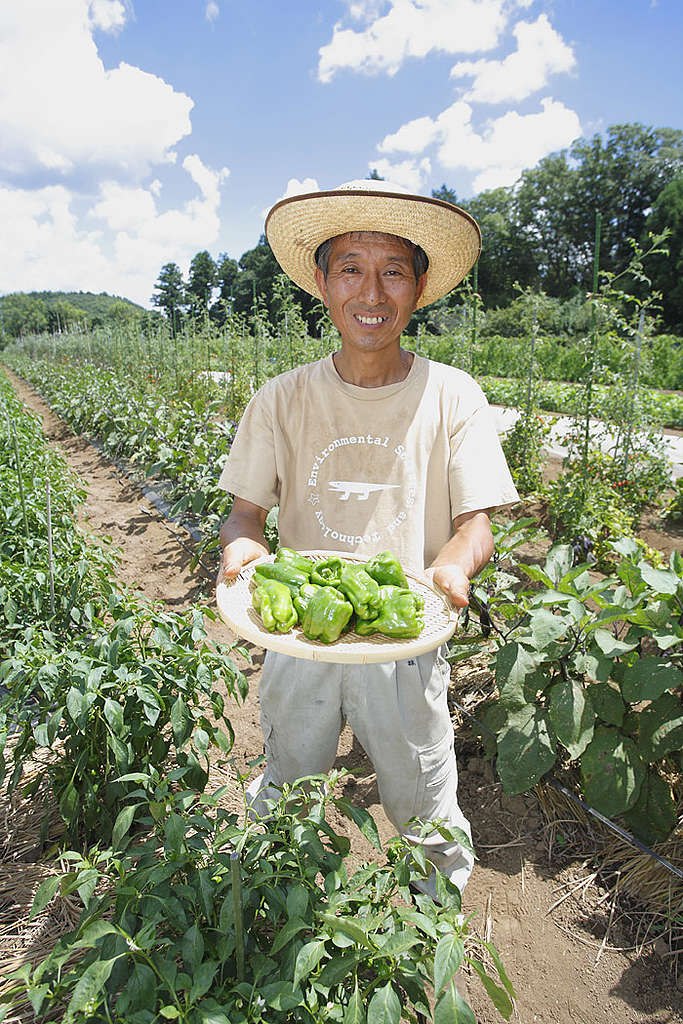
[247,651,473,896]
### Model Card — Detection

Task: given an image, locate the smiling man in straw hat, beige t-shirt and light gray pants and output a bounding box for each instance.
[220,180,517,895]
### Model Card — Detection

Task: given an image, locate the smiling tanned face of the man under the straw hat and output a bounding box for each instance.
[315,231,425,352]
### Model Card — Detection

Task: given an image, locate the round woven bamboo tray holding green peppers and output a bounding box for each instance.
[216,551,458,665]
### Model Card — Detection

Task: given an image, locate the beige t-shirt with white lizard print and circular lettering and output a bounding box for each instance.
[219,355,518,571]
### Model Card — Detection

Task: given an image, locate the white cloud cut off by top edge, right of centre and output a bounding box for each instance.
[317,0,508,82]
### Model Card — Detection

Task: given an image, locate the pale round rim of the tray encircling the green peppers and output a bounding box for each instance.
[216,548,460,665]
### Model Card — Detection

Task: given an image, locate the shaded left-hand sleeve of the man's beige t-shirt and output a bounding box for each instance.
[218,385,280,510]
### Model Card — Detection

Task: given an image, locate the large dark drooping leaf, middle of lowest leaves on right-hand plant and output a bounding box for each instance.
[581,725,645,817]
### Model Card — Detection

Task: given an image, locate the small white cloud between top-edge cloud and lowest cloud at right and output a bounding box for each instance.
[451,14,575,103]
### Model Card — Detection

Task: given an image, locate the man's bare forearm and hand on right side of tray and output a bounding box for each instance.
[427,510,494,608]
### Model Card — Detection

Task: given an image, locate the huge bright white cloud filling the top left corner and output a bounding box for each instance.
[0,0,194,175]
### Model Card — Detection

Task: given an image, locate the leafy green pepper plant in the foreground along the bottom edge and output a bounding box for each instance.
[0,773,514,1024]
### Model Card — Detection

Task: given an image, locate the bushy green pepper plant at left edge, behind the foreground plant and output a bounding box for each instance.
[0,592,247,847]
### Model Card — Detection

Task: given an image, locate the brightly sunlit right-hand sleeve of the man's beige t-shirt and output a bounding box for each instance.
[449,381,519,519]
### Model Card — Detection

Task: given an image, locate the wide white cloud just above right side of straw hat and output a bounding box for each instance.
[374,96,581,191]
